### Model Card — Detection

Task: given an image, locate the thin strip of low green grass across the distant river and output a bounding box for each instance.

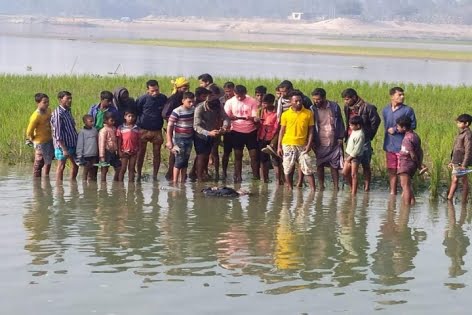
[105,39,472,61]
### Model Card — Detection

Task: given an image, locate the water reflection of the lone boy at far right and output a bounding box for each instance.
[443,201,470,277]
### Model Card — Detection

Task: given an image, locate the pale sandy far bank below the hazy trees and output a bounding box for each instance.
[0,15,472,41]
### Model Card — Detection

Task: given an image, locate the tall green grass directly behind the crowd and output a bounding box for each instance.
[0,75,472,195]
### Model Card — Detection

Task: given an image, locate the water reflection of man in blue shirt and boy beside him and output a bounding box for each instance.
[372,195,419,285]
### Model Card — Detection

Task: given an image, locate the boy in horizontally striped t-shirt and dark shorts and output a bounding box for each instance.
[166,92,195,183]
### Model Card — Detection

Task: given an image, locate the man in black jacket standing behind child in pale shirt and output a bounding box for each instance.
[341,88,380,191]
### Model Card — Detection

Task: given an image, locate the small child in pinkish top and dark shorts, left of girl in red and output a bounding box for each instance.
[98,112,121,182]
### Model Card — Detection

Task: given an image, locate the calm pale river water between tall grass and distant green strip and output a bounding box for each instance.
[0,35,472,85]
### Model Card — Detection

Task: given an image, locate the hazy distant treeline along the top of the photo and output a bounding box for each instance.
[0,0,472,24]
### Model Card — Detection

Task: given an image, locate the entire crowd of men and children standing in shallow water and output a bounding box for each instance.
[27,74,472,204]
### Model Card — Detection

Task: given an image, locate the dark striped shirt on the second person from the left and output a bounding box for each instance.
[51,106,77,148]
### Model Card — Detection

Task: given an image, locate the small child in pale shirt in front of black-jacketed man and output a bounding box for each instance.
[343,116,365,195]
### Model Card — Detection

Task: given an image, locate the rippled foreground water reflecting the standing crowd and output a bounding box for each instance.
[0,167,471,314]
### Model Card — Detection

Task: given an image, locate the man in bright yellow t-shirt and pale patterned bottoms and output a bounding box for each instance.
[277,91,316,191]
